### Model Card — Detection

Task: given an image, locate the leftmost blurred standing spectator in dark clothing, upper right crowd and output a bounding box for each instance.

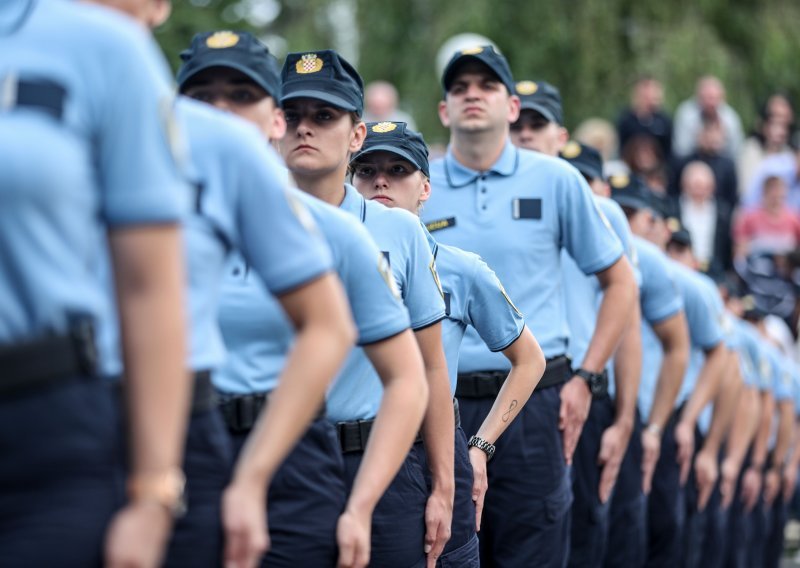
[617,76,672,157]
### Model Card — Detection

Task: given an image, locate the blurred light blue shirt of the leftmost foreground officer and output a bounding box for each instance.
[0,0,187,350]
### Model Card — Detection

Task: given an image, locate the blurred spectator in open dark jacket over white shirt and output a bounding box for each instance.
[678,161,733,275]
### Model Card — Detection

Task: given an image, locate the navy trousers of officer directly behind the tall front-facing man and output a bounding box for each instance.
[569,396,614,568]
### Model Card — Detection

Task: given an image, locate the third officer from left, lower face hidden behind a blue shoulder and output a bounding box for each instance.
[178,32,427,566]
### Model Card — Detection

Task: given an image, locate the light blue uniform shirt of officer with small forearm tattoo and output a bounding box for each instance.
[426,231,525,396]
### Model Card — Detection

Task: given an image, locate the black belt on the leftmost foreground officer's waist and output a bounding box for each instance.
[0,317,97,396]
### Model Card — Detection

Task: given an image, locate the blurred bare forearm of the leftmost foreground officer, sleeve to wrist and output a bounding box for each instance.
[111,228,192,476]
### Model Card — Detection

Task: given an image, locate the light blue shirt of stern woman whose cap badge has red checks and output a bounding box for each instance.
[327,184,445,422]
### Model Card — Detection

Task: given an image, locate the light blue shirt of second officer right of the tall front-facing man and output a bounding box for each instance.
[633,236,683,422]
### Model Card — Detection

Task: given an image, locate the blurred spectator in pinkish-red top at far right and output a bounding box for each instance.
[734,176,800,258]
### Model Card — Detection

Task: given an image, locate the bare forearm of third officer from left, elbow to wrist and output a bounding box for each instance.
[347,346,428,514]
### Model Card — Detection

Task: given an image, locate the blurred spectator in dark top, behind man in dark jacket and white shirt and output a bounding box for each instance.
[669,115,738,210]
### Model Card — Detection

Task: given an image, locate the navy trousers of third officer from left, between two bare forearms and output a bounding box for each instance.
[232,418,346,568]
